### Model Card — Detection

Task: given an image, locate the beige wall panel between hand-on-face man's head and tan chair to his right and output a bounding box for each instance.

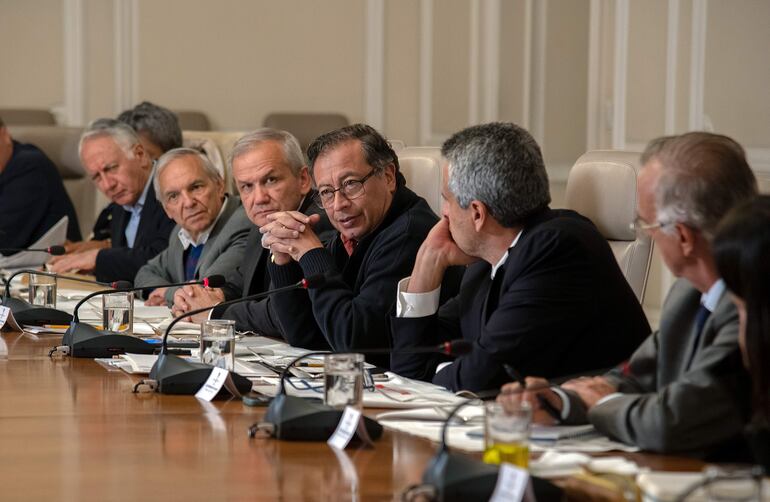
[543,0,589,167]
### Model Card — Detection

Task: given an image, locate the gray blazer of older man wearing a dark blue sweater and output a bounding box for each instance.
[134,196,251,305]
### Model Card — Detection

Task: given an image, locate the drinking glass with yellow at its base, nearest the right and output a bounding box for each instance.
[484,401,532,469]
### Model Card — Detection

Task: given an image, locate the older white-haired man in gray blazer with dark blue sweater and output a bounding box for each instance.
[134,148,251,306]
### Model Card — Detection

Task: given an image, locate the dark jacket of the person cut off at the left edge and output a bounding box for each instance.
[0,141,80,250]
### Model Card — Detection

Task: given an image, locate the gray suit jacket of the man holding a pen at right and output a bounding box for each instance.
[568,279,750,457]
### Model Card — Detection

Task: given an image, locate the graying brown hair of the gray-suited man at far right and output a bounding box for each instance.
[641,132,757,241]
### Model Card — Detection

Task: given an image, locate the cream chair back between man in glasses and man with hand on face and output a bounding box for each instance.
[396,146,441,215]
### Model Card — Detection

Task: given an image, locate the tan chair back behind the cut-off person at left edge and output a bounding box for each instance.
[8,126,95,238]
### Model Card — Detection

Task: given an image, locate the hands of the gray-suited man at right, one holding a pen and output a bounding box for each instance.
[497,376,617,425]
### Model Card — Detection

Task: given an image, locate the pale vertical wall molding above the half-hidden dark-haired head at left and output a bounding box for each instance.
[112,0,139,114]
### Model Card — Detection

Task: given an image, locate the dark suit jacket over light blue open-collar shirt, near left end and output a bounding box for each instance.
[94,186,175,282]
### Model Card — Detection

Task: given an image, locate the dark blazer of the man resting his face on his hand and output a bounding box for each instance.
[391,209,650,391]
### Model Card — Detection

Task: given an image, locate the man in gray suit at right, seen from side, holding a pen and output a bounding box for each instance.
[498,132,757,458]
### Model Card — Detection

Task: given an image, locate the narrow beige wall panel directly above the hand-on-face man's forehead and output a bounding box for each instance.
[431,0,470,135]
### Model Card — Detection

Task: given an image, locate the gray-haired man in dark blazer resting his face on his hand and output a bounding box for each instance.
[392,123,649,391]
